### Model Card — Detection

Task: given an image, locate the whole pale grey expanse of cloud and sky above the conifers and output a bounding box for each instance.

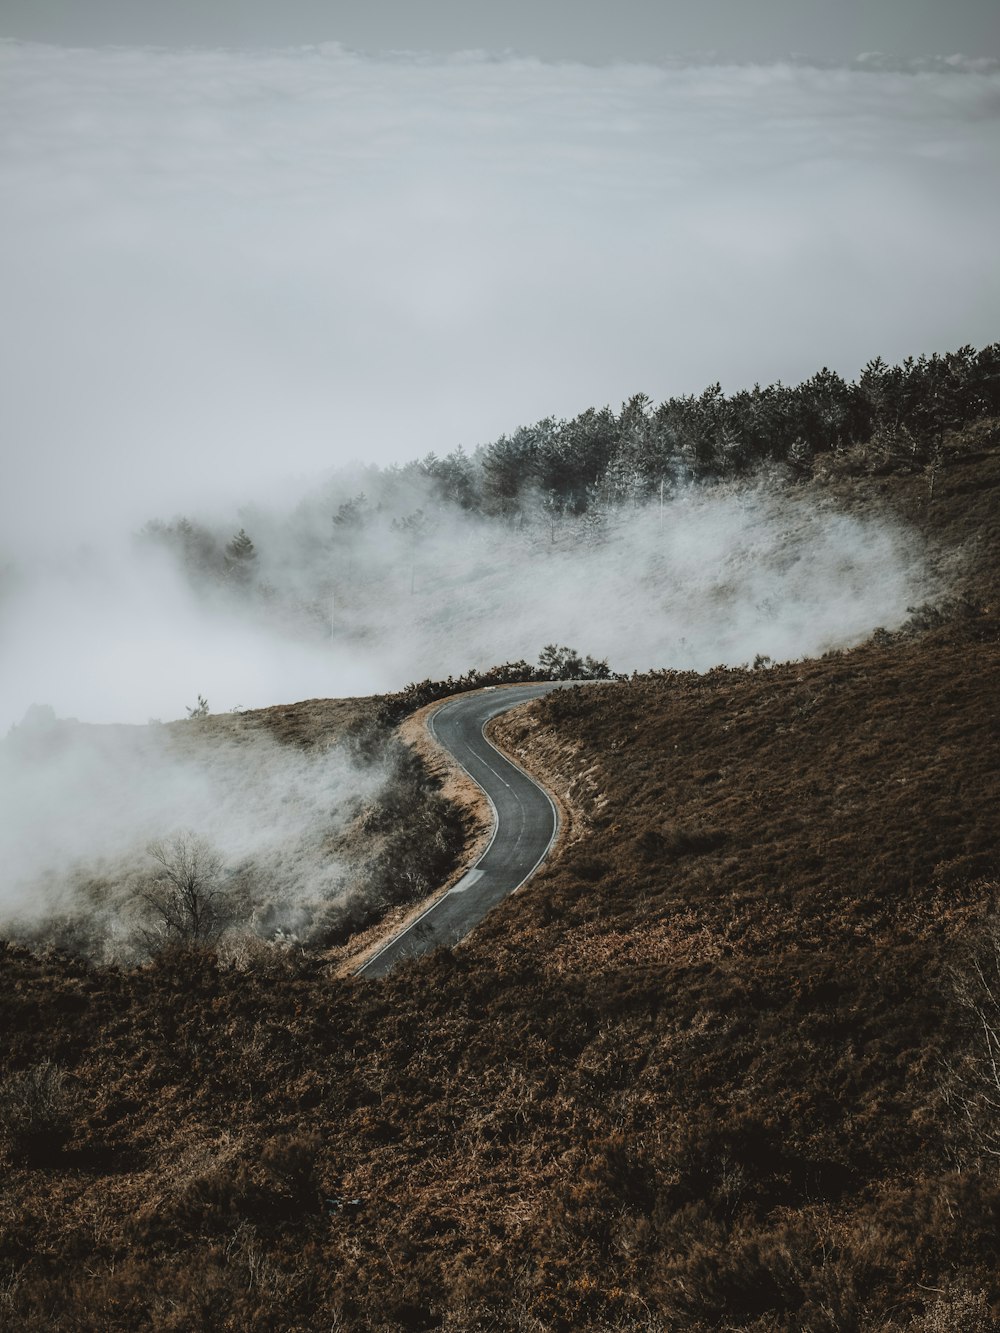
[0,0,1000,559]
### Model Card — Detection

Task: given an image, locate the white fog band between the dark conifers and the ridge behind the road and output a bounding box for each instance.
[1,471,927,725]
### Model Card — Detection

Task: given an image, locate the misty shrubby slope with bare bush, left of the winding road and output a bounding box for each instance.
[0,700,469,965]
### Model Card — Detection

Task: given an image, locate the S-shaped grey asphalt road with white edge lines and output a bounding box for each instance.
[356,681,561,977]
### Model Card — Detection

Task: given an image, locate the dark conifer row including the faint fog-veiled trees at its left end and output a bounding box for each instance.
[143,343,1000,597]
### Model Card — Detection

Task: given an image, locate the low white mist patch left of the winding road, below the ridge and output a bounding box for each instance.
[0,708,384,952]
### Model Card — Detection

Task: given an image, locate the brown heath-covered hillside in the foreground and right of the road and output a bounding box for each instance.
[0,423,1000,1333]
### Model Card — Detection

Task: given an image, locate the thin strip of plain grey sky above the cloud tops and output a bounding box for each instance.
[0,0,1000,64]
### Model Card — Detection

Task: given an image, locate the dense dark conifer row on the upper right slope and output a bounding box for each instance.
[416,343,1000,515]
